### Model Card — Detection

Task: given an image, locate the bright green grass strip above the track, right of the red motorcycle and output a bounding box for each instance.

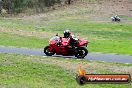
[89,40,132,55]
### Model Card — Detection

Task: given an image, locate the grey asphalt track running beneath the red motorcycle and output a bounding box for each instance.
[0,46,132,64]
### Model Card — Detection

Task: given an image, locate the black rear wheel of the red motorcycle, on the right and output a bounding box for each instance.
[75,47,88,58]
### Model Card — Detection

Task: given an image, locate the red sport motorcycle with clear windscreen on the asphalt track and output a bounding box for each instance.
[44,36,88,58]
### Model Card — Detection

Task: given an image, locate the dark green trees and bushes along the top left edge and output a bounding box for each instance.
[0,0,72,13]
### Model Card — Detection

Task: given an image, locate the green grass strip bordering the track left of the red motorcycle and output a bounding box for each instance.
[0,33,48,48]
